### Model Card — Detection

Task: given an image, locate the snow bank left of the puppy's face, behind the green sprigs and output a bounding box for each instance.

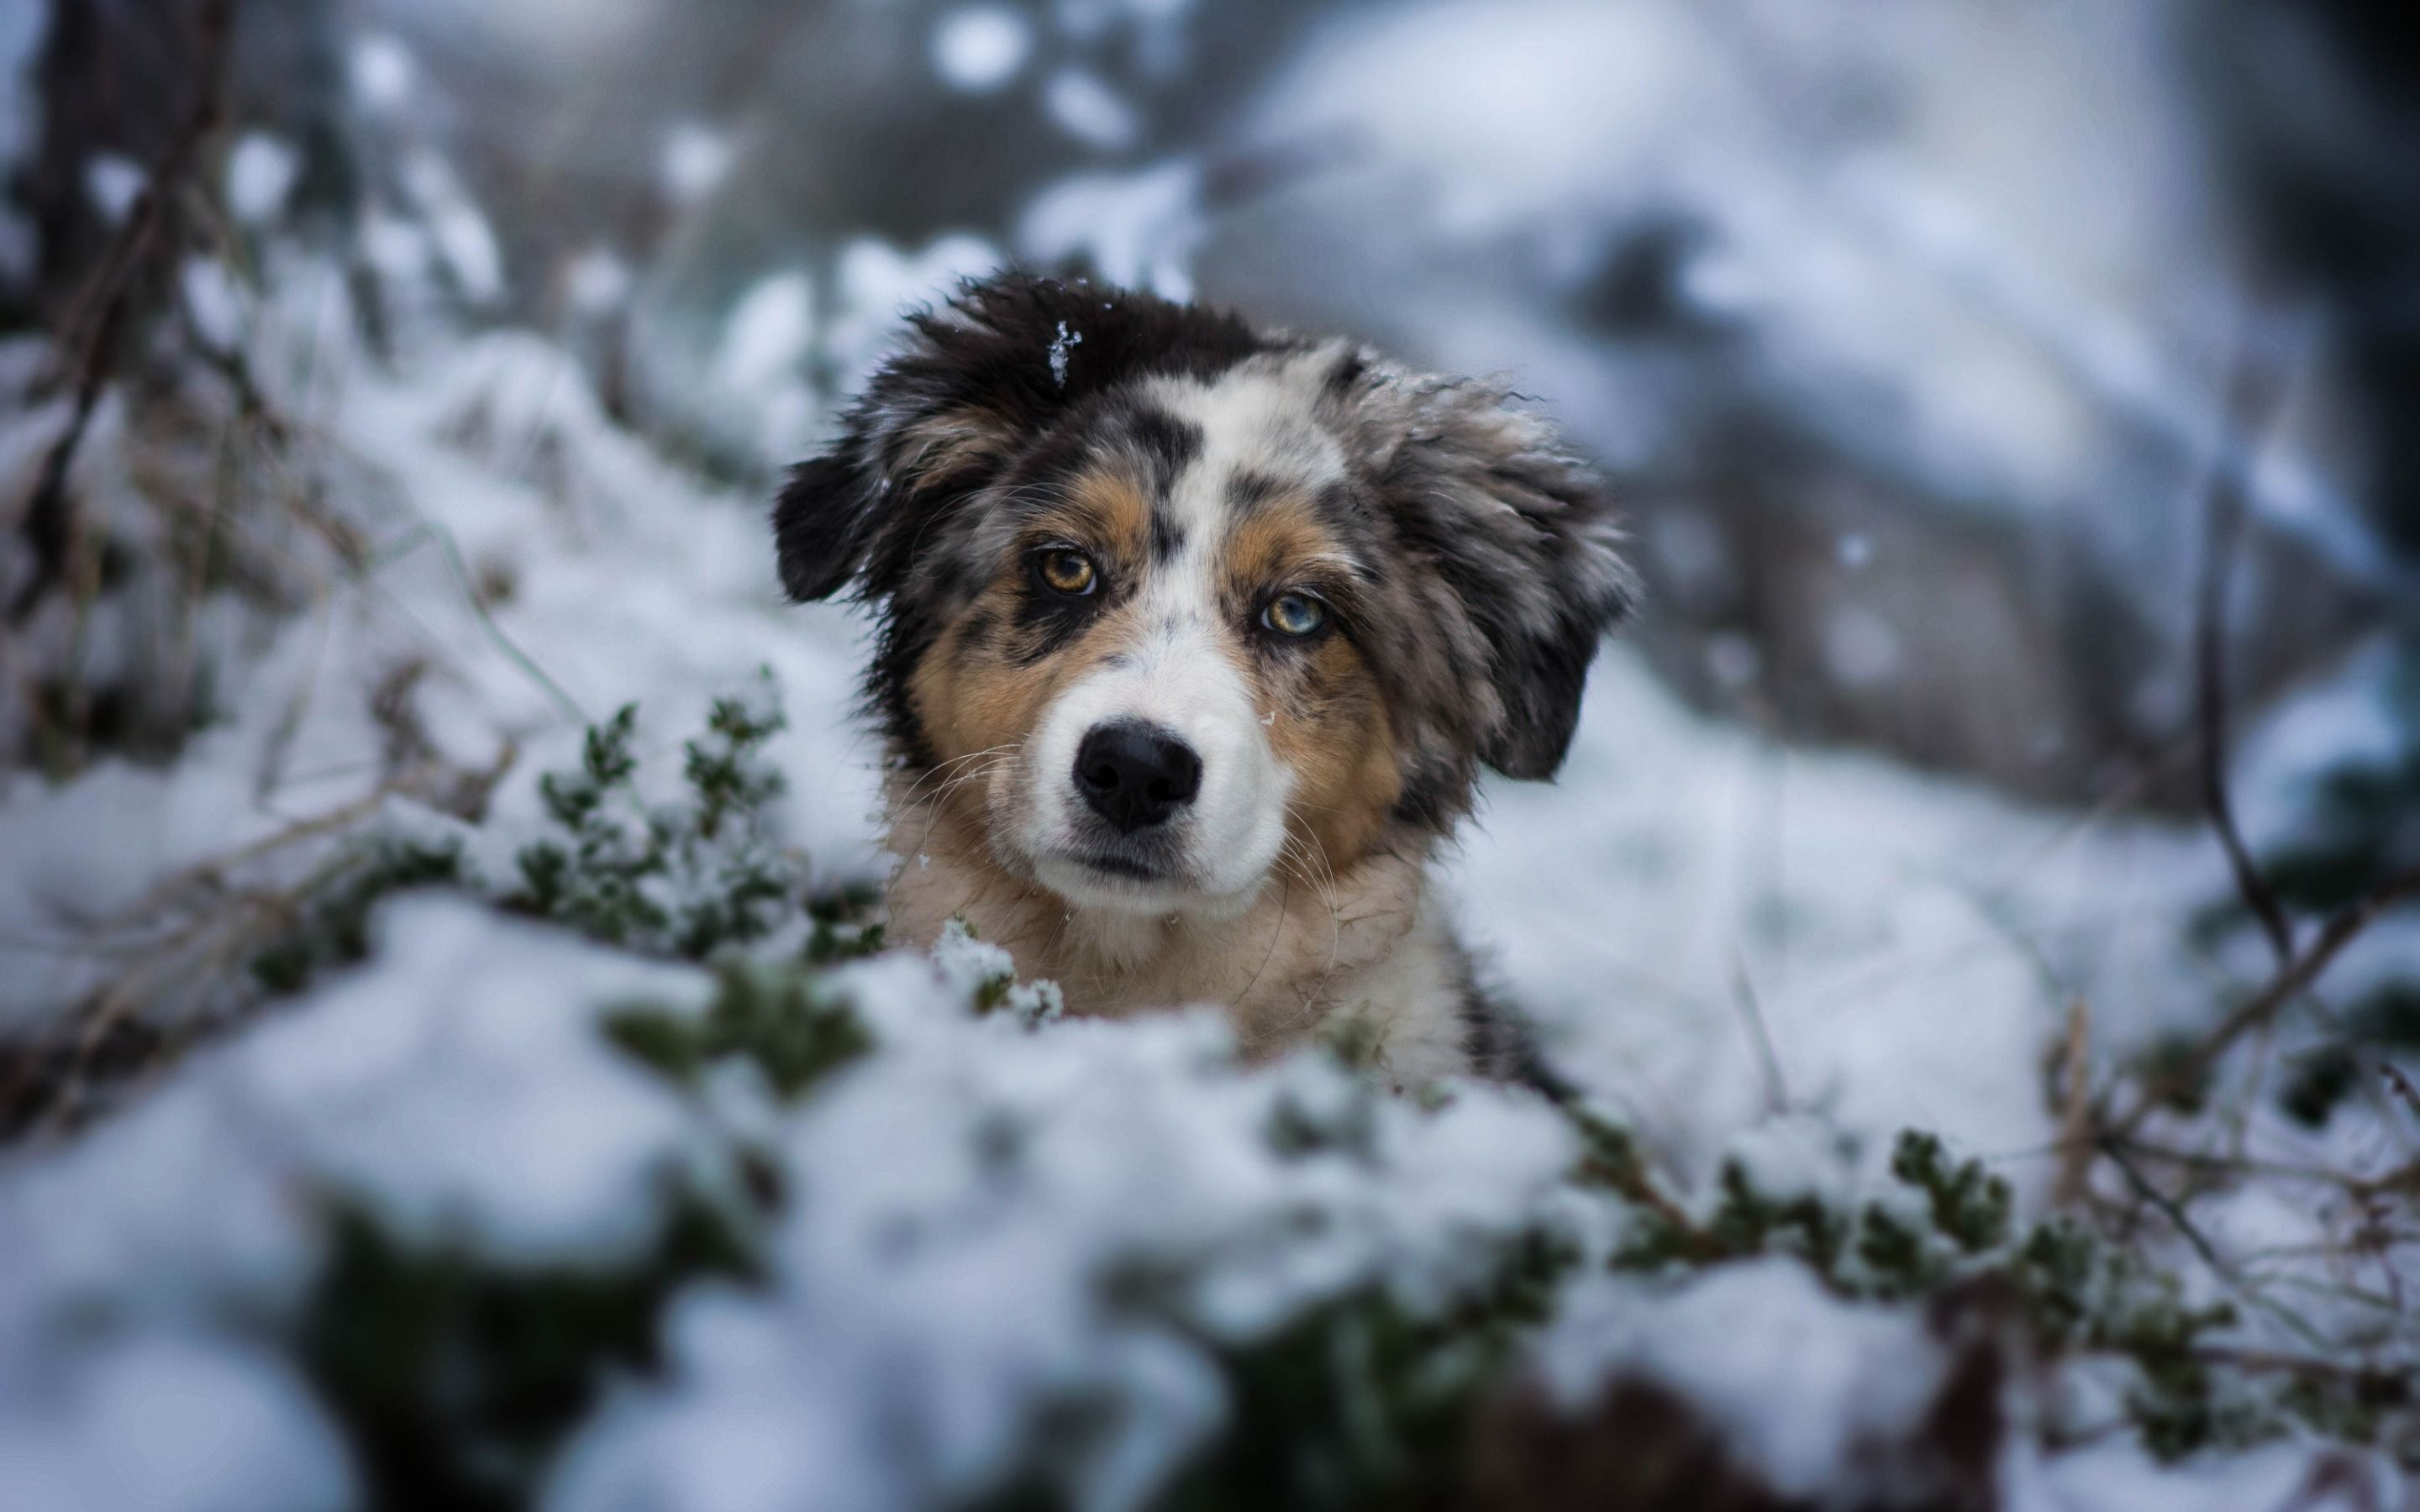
[0,281,874,1026]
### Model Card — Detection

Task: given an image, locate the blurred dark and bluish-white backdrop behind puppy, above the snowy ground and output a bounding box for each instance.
[0,0,2420,811]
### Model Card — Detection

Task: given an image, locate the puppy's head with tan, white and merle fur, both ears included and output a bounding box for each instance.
[775,273,1631,912]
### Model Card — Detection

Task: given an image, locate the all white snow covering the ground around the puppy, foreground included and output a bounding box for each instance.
[0,227,2410,1512]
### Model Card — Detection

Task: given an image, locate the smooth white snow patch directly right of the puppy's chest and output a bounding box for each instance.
[1452,648,2217,1176]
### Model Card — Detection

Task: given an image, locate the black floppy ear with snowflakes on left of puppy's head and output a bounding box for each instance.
[772,271,1265,602]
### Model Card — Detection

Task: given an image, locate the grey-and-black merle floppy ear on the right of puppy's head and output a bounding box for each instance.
[1367,375,1639,779]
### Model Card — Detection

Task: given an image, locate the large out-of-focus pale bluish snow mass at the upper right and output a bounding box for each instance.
[1239,0,2408,597]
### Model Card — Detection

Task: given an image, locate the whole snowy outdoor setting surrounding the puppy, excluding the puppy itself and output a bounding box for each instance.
[0,0,2420,1512]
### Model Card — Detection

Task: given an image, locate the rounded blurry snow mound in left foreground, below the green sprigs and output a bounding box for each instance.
[237,900,707,1260]
